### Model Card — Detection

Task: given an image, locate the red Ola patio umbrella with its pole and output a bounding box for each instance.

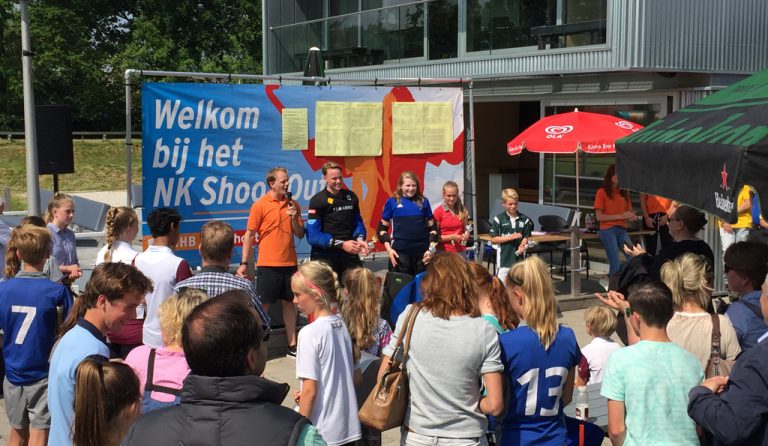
[507,109,643,297]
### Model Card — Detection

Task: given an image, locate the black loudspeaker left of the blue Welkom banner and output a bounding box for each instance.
[35,105,75,175]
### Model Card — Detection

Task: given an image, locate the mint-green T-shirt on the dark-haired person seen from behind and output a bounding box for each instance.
[600,341,704,446]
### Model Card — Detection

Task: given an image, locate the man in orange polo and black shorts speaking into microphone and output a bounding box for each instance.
[237,167,304,357]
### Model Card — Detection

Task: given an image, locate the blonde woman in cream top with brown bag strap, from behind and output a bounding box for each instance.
[661,253,741,368]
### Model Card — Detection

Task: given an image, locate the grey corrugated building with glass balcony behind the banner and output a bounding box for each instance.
[263,0,768,218]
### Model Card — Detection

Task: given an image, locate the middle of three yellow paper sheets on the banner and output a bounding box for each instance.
[315,101,382,156]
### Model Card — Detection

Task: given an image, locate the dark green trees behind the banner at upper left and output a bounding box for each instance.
[0,0,262,130]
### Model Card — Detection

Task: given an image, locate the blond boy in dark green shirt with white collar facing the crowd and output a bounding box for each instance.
[490,189,533,280]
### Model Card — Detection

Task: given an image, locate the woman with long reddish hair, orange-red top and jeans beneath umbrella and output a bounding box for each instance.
[595,164,637,276]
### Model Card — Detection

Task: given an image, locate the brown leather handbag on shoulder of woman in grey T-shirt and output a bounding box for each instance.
[358,304,421,431]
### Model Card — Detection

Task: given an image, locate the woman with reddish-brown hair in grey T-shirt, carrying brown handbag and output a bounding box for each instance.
[379,252,504,446]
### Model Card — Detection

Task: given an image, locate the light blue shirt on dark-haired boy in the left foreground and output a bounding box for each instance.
[48,320,109,446]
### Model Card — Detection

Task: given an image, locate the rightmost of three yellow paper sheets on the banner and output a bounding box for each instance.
[392,102,453,155]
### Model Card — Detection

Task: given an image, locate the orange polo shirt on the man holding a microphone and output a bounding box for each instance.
[248,192,301,266]
